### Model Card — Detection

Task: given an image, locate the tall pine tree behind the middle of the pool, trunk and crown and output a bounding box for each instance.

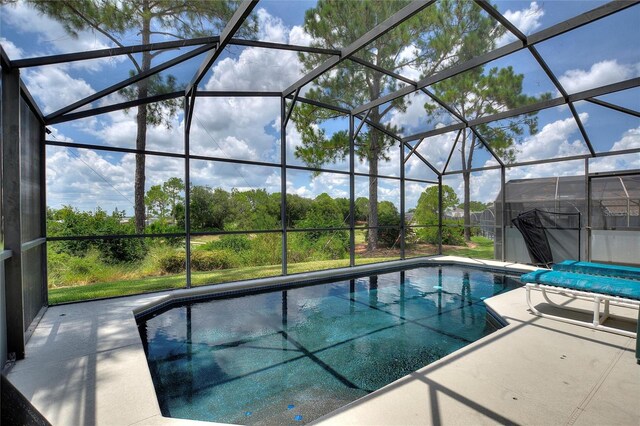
[293,0,501,250]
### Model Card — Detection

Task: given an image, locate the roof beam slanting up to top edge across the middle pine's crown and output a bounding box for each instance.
[282,0,435,95]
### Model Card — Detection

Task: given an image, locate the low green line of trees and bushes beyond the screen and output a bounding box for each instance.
[47,177,484,262]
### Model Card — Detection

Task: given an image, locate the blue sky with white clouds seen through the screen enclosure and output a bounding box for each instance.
[0,0,640,212]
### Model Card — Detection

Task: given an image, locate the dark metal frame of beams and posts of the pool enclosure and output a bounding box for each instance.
[0,0,640,357]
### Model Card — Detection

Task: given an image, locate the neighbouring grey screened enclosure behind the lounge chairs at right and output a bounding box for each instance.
[496,172,640,265]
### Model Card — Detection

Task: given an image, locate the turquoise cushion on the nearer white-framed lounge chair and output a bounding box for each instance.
[520,269,640,300]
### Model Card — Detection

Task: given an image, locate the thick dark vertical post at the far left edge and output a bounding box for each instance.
[1,68,26,359]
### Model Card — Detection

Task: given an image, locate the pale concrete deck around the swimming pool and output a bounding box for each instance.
[8,257,640,425]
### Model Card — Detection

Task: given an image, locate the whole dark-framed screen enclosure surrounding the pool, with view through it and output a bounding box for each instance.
[0,0,640,359]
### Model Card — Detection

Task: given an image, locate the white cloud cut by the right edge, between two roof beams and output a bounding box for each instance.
[558,60,640,93]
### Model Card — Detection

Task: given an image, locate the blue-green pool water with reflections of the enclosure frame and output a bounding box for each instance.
[139,266,521,425]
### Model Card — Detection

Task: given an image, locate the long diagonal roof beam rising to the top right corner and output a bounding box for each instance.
[352,1,639,115]
